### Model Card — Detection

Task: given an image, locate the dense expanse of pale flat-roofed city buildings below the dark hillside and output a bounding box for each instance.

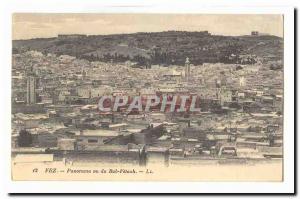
[11,49,283,165]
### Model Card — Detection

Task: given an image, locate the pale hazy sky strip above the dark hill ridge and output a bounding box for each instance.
[12,14,283,39]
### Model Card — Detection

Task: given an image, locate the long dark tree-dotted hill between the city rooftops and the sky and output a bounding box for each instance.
[13,31,283,65]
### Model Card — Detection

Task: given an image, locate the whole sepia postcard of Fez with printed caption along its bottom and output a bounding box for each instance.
[11,13,285,182]
